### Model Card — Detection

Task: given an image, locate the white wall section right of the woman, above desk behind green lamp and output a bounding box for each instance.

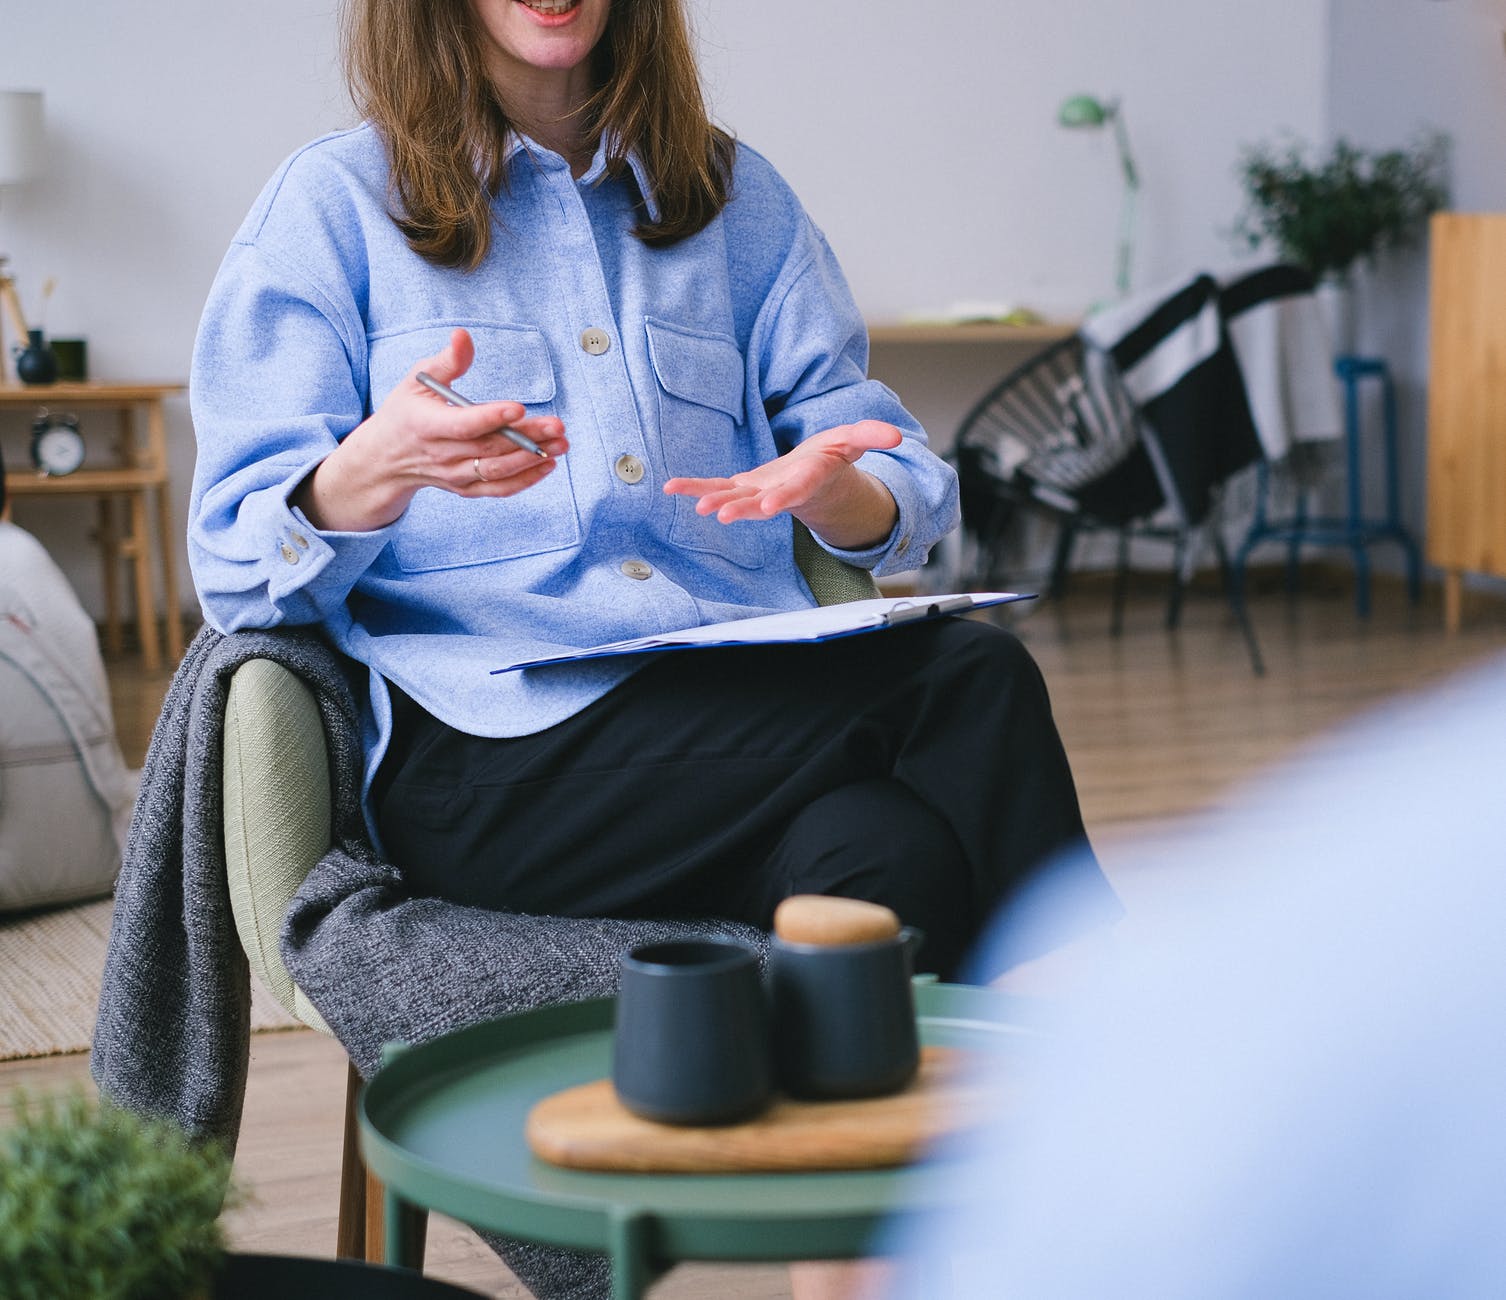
[697,0,1327,319]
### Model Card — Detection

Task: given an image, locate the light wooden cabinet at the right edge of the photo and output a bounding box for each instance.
[1428,212,1506,631]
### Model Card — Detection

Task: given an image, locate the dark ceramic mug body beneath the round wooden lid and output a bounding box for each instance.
[770,926,922,1100]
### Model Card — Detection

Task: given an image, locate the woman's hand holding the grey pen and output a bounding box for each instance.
[292,330,569,533]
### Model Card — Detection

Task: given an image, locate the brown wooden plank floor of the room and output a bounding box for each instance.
[0,572,1506,1300]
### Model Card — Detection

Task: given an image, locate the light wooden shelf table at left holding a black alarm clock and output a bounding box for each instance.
[0,383,184,672]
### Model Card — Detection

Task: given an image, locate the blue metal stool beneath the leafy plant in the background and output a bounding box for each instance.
[1232,356,1422,618]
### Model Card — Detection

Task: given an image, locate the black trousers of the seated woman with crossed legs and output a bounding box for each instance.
[375,619,1117,978]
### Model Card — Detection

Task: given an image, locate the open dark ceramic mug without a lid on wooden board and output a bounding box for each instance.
[611,940,773,1124]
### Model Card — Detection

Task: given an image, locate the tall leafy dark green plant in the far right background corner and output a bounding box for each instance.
[1236,133,1449,280]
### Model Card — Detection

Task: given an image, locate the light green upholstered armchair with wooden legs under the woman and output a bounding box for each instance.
[224,524,878,1259]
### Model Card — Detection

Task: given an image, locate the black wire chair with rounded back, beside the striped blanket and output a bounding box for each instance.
[950,334,1265,673]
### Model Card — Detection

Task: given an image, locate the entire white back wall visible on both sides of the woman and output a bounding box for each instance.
[0,0,1506,626]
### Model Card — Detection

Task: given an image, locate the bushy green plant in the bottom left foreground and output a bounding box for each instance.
[0,1094,238,1300]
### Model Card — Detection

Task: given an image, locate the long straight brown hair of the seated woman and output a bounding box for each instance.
[343,0,733,270]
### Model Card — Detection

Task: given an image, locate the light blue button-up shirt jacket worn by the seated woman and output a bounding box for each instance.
[188,124,958,780]
